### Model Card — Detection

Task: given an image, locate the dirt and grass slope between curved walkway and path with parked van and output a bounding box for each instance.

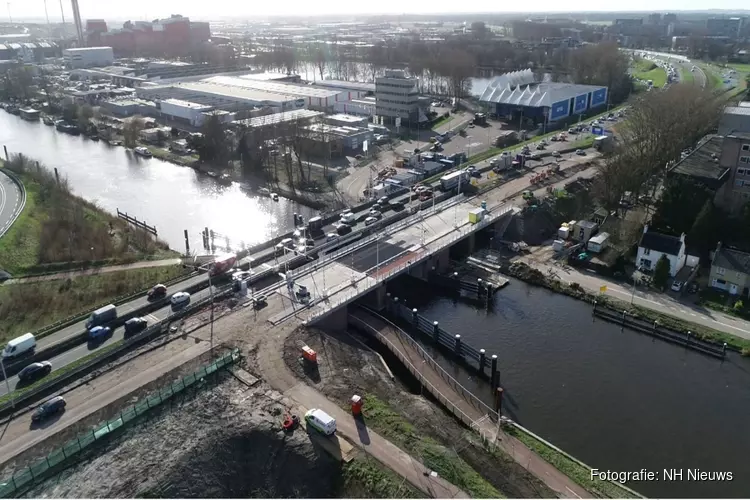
[284,328,555,498]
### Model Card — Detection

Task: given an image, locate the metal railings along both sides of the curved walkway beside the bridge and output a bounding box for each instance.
[349,312,497,428]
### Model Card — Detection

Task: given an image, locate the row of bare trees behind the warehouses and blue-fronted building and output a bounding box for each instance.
[250,39,631,101]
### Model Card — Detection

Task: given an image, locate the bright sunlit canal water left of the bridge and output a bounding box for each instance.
[0,111,314,251]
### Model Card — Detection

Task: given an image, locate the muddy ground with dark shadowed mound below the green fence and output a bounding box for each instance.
[25,372,394,498]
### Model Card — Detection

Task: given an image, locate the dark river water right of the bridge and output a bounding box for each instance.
[390,280,750,498]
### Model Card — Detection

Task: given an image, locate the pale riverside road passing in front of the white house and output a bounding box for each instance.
[518,257,750,340]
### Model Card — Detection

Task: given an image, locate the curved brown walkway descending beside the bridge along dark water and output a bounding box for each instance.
[349,308,591,498]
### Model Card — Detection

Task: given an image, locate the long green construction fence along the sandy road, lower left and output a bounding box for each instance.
[0,349,241,498]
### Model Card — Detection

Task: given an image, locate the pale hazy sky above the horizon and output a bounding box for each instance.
[5,0,750,21]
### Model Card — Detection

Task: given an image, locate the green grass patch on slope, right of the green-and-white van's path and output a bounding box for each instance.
[363,394,503,498]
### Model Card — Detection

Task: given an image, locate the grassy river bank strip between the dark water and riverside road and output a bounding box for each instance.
[500,261,750,356]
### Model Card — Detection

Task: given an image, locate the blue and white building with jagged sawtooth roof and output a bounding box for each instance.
[479,69,607,124]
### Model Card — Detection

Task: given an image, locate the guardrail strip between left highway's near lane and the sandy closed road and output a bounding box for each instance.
[0,285,232,417]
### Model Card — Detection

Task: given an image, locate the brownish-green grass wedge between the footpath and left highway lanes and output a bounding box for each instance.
[0,266,186,343]
